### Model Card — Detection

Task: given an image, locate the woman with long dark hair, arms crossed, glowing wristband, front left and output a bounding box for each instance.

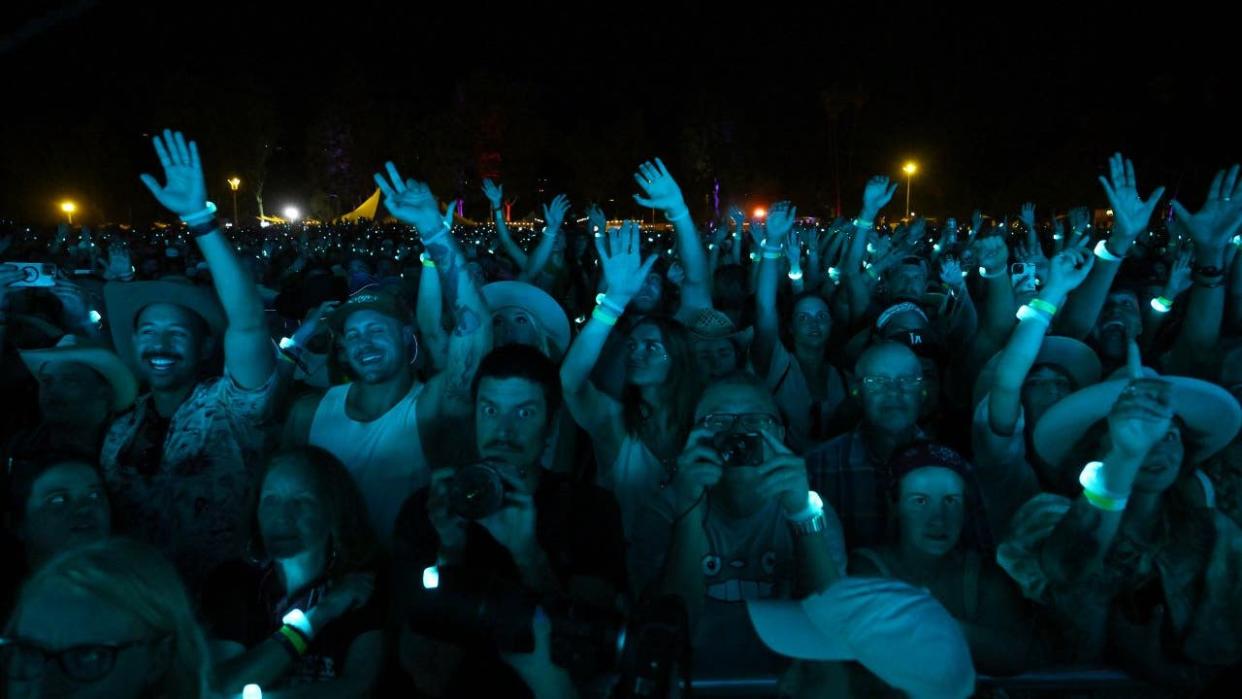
[202,447,385,697]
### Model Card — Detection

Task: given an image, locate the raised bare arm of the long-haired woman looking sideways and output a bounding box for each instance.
[560,227,656,444]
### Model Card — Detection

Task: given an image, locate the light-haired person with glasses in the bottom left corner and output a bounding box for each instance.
[0,539,207,699]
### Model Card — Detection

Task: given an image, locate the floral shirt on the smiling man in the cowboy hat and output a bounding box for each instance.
[99,371,277,589]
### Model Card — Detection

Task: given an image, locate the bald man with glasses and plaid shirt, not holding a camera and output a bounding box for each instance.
[806,341,925,548]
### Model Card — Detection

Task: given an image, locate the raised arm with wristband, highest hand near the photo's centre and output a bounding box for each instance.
[633,158,712,309]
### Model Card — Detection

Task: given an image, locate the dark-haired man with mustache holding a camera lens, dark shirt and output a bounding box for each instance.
[394,344,628,697]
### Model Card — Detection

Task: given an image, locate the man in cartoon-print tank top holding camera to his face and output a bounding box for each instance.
[630,374,846,677]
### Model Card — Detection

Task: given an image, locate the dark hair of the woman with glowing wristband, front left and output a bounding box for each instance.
[246,447,379,579]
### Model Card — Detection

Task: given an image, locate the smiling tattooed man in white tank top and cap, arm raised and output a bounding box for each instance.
[284,164,492,546]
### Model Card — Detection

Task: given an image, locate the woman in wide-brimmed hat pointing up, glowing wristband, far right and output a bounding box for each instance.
[997,377,1242,688]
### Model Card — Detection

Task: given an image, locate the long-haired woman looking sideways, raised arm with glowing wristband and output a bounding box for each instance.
[560,222,698,531]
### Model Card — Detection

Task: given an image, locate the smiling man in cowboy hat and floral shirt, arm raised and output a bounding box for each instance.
[99,132,276,589]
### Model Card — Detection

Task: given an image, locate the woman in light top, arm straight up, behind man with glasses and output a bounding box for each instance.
[754,202,846,453]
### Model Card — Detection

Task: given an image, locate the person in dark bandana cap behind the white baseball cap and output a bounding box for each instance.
[850,443,1045,674]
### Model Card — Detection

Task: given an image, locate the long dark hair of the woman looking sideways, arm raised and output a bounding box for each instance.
[621,315,702,437]
